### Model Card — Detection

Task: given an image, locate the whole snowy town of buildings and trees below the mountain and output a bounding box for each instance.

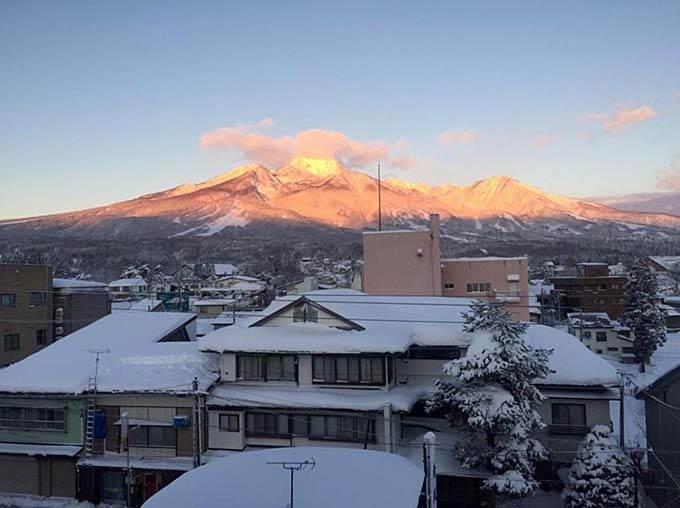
[0,214,680,508]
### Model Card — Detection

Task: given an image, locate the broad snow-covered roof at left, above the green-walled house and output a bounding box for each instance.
[0,312,217,394]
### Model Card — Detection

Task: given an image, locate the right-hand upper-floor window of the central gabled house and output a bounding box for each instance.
[312,355,385,384]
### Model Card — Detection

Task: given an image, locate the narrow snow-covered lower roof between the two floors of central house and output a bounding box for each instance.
[208,381,434,412]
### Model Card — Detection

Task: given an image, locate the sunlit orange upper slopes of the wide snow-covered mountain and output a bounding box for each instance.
[0,157,680,237]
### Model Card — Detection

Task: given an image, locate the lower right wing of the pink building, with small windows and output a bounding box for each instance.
[442,257,529,321]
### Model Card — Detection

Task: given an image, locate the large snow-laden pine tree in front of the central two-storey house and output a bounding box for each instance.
[429,301,552,498]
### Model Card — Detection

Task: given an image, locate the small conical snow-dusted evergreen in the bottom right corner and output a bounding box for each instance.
[562,425,635,508]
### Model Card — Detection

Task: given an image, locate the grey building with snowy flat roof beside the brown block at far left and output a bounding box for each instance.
[52,277,111,340]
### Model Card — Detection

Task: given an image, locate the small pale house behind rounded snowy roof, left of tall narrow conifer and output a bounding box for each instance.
[567,312,635,363]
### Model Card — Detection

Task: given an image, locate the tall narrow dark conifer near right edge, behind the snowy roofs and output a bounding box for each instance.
[619,259,666,372]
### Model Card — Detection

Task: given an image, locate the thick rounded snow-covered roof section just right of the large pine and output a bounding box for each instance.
[525,325,618,386]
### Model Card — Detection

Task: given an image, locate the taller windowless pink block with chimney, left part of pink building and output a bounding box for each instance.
[362,216,442,296]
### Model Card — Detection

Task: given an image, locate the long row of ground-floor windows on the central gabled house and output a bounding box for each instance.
[246,413,375,442]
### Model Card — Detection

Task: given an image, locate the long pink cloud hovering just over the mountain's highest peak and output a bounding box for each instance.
[201,118,415,168]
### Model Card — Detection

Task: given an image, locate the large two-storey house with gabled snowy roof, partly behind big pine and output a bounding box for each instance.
[201,290,617,507]
